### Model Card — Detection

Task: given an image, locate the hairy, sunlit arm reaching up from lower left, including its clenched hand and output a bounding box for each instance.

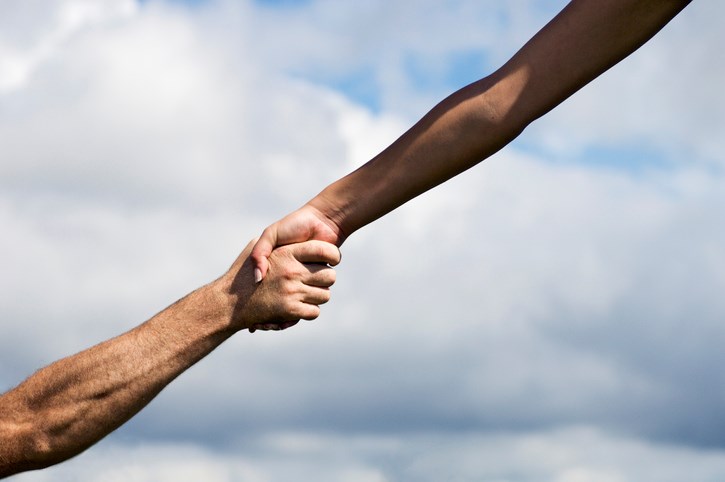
[0,241,339,478]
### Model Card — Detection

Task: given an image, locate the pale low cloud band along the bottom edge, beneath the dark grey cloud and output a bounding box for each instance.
[15,427,725,482]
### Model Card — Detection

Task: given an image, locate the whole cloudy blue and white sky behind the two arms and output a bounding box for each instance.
[0,0,725,482]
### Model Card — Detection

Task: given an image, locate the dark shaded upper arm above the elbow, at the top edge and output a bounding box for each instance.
[498,0,690,123]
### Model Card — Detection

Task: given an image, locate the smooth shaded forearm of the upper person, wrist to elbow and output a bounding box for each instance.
[309,76,525,237]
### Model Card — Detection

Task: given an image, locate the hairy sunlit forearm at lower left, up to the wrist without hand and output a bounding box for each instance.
[0,286,232,477]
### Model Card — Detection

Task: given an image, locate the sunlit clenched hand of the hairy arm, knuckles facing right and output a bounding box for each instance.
[218,240,340,333]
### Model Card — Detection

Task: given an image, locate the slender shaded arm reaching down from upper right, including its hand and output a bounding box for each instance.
[252,0,689,279]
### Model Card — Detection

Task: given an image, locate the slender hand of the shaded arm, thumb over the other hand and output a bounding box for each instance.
[251,204,344,283]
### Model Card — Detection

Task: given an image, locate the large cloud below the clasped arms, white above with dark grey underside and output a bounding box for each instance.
[85,152,725,446]
